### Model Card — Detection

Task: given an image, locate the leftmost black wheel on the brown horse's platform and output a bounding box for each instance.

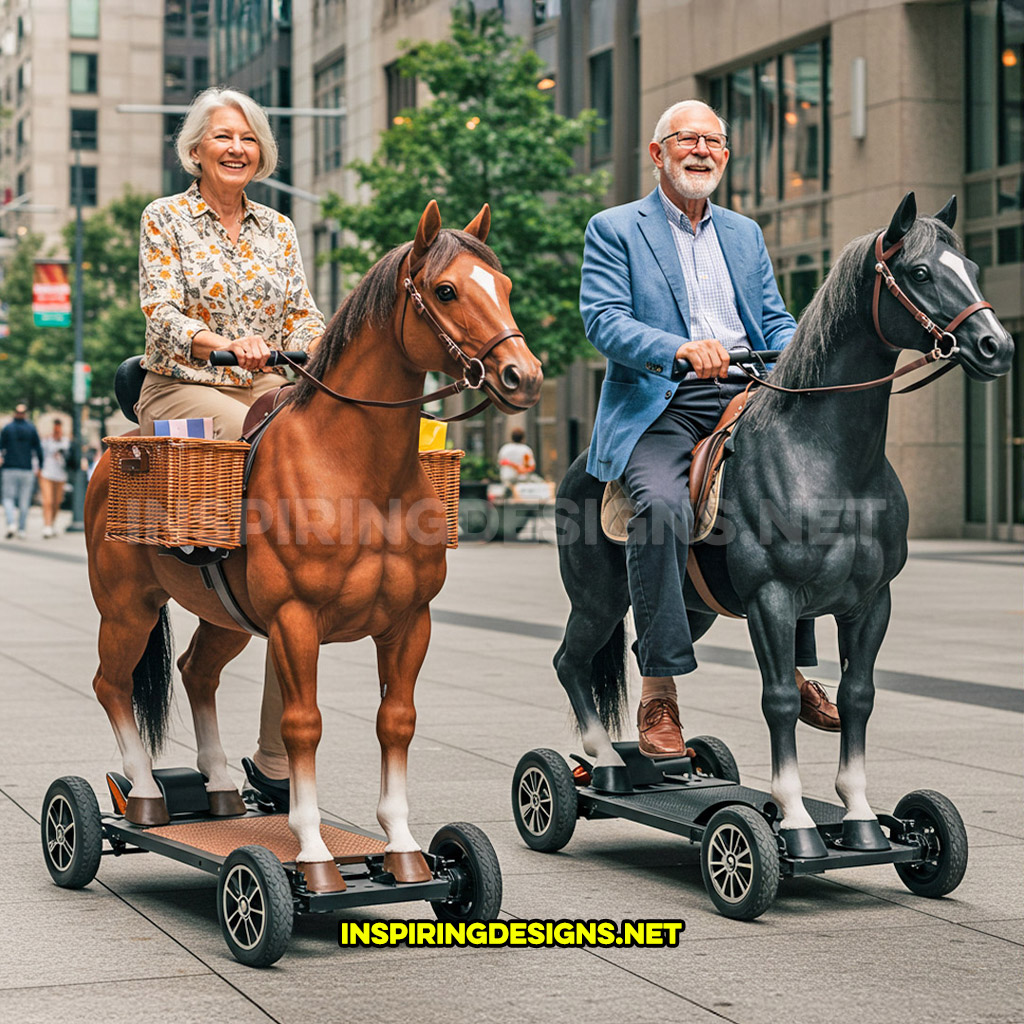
[40,775,103,889]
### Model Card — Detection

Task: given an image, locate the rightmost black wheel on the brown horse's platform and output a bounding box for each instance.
[430,821,502,924]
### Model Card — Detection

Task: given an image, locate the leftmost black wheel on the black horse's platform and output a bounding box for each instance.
[512,748,580,853]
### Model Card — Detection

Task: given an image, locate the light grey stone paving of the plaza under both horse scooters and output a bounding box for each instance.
[0,512,1024,1024]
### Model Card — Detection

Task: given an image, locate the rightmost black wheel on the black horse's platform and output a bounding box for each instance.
[893,790,968,899]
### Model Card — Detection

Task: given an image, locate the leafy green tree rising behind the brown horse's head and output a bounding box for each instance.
[324,5,608,375]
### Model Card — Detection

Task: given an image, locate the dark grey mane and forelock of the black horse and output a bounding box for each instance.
[744,217,961,429]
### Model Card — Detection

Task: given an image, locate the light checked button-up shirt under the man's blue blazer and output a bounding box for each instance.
[657,185,751,380]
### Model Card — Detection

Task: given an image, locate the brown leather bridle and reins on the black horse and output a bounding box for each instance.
[740,231,992,394]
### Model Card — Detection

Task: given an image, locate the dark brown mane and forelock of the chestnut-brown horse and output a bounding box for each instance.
[290,228,502,408]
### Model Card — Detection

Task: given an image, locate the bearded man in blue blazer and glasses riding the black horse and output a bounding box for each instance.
[580,99,839,758]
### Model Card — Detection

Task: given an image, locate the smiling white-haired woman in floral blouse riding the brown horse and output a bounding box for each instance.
[135,88,325,794]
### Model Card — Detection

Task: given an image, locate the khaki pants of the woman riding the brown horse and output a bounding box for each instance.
[135,373,288,778]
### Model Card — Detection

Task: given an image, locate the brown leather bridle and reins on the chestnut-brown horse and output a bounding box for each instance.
[278,250,525,423]
